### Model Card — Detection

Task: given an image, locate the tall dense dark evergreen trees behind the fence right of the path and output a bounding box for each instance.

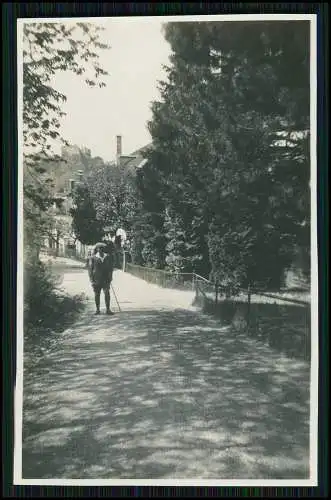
[145,22,309,286]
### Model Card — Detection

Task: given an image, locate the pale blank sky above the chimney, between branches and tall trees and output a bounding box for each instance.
[54,18,171,161]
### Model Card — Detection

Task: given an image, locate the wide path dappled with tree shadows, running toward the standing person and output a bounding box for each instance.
[23,266,309,479]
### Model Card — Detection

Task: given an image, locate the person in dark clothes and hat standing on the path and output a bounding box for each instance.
[88,243,114,315]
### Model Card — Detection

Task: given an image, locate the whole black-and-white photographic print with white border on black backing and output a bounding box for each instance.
[14,14,319,486]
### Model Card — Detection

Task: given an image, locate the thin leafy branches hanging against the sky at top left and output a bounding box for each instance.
[23,23,107,162]
